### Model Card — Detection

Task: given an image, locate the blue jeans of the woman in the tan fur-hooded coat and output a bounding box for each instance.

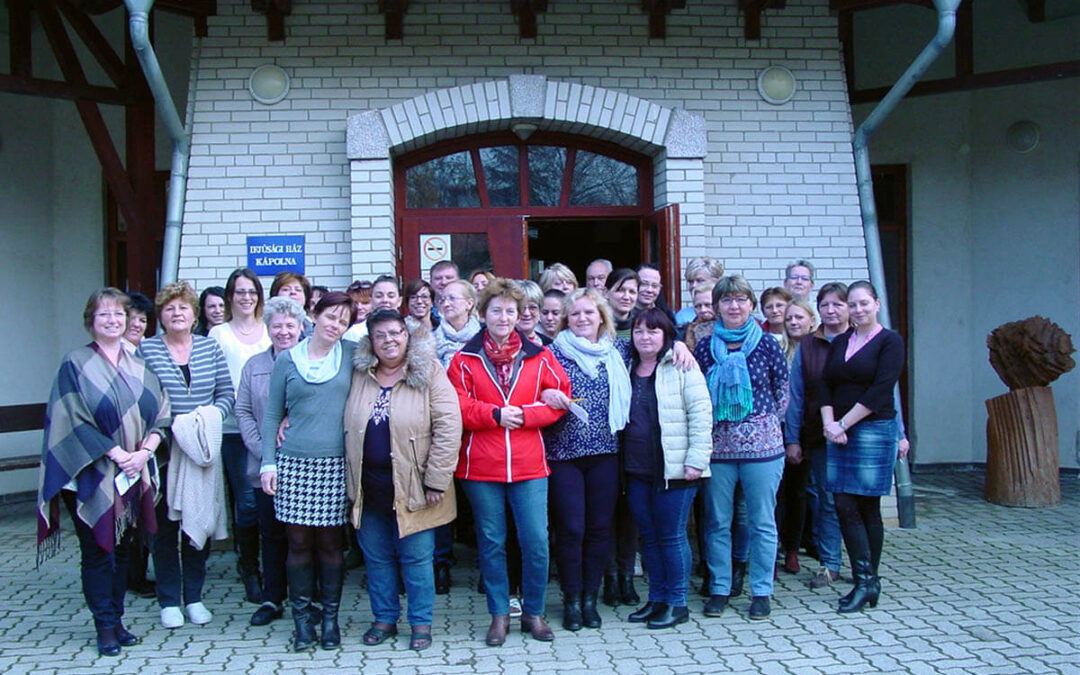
[356,509,435,625]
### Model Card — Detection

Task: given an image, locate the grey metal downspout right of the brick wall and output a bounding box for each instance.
[853,0,961,528]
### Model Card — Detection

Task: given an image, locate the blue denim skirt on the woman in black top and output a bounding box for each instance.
[825,419,897,497]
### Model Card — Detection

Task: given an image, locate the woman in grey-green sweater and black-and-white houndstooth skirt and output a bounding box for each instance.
[259,292,355,651]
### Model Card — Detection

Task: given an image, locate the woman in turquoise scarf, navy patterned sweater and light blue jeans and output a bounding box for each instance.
[694,274,789,619]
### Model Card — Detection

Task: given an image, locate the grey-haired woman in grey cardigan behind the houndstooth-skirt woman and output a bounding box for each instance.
[235,297,307,625]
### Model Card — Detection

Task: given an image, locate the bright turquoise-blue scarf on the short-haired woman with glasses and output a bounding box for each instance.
[708,318,765,422]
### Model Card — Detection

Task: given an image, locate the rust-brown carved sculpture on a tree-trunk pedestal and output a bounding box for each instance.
[985,316,1076,507]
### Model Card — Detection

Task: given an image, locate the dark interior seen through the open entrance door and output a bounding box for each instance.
[528,218,642,285]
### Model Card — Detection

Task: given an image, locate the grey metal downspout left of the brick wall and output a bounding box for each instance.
[124,0,190,285]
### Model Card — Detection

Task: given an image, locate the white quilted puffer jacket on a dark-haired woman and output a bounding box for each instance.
[656,350,713,481]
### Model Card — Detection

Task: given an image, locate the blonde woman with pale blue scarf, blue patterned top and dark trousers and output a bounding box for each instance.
[544,288,631,631]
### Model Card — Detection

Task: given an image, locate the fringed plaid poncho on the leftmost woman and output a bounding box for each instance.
[38,343,168,564]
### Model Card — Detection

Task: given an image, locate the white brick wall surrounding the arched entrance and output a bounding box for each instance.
[180,0,866,287]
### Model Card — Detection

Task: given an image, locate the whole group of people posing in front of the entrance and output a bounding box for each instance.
[38,258,906,656]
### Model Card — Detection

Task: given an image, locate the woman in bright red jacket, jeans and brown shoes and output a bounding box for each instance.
[447,279,570,647]
